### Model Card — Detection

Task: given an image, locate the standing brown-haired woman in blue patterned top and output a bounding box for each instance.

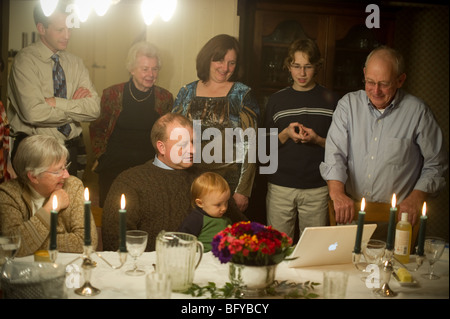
[172,34,259,212]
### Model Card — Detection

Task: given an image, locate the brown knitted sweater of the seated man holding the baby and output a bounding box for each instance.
[102,160,246,251]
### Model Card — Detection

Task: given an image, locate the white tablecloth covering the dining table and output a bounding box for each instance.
[12,248,449,299]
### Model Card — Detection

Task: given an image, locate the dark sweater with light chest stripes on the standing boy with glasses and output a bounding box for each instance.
[266,85,337,189]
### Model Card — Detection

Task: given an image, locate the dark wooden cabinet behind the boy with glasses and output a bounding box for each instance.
[238,0,394,107]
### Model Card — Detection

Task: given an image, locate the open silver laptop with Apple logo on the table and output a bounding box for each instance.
[288,224,377,268]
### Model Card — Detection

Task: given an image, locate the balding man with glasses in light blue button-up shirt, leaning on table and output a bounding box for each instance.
[320,46,448,225]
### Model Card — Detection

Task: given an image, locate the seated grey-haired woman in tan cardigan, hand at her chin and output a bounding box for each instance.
[0,135,97,256]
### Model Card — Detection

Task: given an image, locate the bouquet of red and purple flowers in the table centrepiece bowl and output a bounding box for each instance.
[211,222,293,266]
